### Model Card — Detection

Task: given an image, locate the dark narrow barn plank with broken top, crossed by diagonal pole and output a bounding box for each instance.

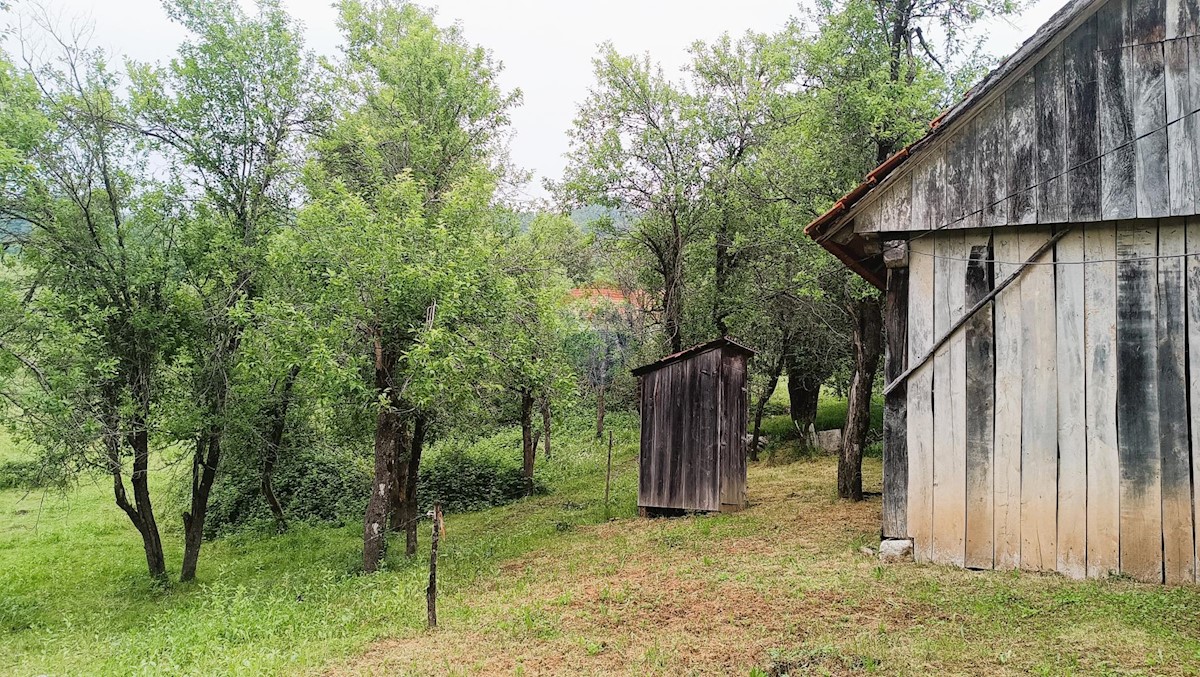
[964,230,996,569]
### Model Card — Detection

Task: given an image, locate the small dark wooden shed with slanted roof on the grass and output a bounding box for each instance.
[634,339,754,515]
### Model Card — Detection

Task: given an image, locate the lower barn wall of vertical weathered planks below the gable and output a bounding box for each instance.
[902,217,1200,583]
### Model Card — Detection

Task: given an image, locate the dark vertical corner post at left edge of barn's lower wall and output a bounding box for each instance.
[883,266,908,539]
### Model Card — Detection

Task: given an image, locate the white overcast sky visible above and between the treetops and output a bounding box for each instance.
[7,0,1064,197]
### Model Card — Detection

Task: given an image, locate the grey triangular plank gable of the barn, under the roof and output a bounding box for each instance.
[852,0,1200,233]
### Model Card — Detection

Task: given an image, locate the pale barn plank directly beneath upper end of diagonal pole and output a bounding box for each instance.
[1055,226,1087,579]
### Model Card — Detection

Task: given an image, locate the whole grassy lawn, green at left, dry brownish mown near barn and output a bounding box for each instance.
[0,419,1200,675]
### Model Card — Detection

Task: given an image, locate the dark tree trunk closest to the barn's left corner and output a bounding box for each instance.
[838,296,883,501]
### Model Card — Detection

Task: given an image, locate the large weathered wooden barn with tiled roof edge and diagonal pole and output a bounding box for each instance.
[808,0,1200,583]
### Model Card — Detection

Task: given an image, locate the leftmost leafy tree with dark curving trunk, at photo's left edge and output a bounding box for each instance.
[0,34,182,580]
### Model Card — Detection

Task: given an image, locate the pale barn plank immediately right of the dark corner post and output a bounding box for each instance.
[907,235,940,562]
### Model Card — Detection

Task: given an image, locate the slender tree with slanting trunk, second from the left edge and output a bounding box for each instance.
[131,0,314,581]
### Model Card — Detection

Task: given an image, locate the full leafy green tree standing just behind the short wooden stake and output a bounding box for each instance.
[297,0,520,571]
